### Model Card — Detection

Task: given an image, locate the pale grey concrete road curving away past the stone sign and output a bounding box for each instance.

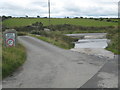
[2,36,107,88]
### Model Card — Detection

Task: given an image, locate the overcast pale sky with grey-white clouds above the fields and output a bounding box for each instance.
[0,0,119,17]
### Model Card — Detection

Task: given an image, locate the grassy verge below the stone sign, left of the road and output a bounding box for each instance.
[2,44,26,78]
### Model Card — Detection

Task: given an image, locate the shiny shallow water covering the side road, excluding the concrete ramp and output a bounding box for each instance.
[67,33,109,48]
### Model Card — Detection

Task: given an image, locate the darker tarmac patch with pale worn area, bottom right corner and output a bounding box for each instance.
[81,56,118,88]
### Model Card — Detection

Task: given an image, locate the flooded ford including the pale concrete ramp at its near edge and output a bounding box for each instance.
[69,33,114,58]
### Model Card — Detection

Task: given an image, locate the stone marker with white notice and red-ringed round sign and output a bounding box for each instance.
[3,29,17,47]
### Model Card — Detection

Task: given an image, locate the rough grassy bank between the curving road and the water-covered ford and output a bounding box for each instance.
[32,31,78,49]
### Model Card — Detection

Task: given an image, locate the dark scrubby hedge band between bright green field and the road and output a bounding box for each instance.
[3,22,115,34]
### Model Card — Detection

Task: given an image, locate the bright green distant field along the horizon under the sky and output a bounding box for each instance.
[3,18,118,28]
